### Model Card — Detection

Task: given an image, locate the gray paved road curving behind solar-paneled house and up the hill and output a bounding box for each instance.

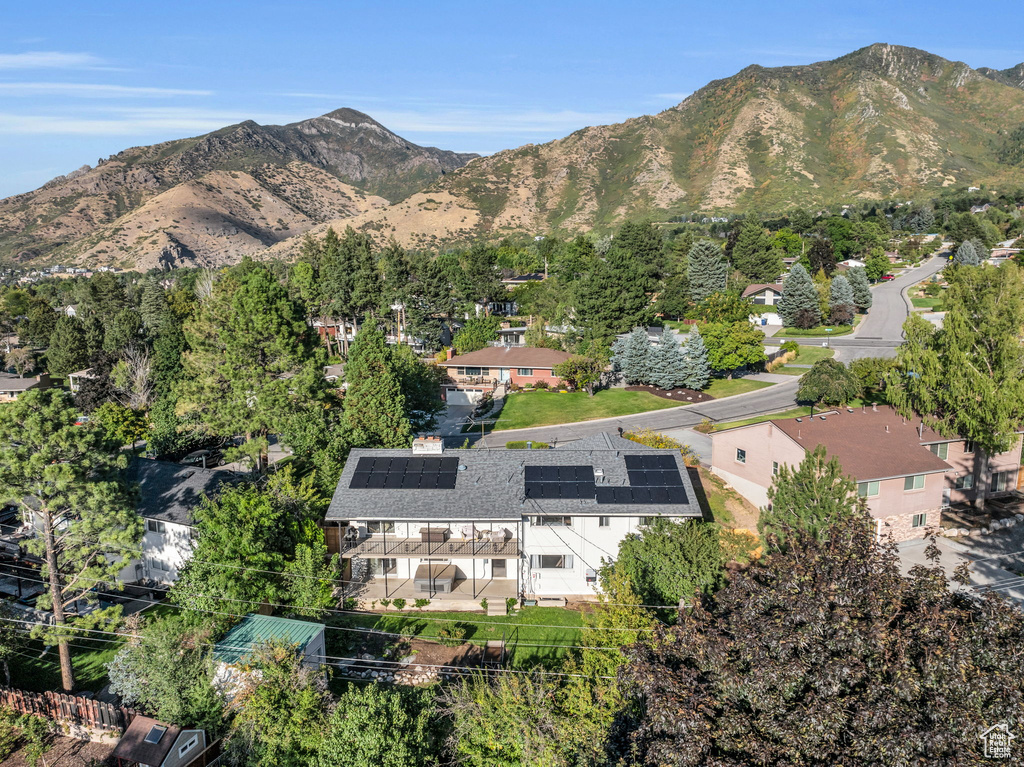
[477,256,947,448]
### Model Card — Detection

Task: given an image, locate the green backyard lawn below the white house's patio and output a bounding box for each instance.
[324,607,583,668]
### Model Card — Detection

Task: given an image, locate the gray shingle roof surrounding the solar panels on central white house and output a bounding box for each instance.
[327,434,700,521]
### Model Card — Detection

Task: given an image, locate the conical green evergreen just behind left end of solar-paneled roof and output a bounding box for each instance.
[343,326,413,448]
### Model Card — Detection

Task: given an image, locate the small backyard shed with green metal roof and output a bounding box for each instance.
[213,614,327,687]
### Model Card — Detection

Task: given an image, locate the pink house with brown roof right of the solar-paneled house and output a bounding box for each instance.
[712,407,1021,541]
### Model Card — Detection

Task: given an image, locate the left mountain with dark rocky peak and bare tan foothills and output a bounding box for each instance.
[0,110,476,266]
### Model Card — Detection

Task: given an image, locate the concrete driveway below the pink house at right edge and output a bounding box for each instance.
[899,524,1024,605]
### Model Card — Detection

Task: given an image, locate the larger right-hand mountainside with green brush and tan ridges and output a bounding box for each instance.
[284,44,1024,252]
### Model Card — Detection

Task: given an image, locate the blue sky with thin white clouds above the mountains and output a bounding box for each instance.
[0,0,1024,197]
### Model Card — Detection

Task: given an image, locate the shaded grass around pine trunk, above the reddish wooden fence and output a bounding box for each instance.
[8,638,124,692]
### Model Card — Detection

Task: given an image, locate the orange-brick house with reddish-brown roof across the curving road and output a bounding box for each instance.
[439,346,571,404]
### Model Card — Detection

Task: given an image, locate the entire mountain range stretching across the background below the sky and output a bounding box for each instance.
[0,44,1024,268]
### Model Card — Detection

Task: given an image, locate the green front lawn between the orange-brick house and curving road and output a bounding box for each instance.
[493,389,679,431]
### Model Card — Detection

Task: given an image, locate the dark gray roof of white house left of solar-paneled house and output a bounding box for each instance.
[128,458,237,524]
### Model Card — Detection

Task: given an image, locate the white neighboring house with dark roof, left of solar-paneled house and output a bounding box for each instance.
[121,458,234,584]
